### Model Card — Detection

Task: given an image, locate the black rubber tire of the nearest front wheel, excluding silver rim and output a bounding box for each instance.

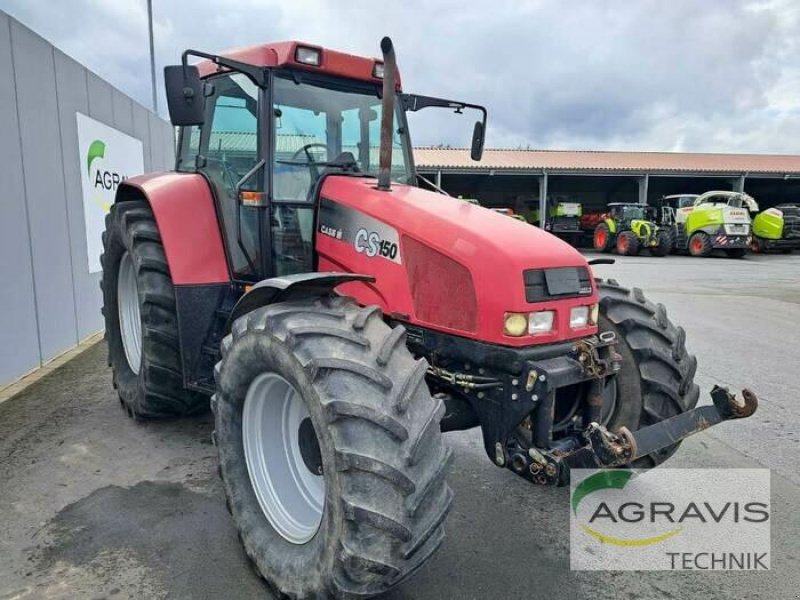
[212,297,453,598]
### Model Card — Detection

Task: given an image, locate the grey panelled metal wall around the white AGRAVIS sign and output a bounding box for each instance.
[0,11,174,387]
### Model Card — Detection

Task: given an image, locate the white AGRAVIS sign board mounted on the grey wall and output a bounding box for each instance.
[76,113,144,273]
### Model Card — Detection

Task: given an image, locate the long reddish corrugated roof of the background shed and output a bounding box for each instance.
[414,147,800,175]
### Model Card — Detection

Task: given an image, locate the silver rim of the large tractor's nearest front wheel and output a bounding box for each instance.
[242,373,325,544]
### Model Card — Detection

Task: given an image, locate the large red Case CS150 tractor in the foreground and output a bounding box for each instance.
[102,38,756,598]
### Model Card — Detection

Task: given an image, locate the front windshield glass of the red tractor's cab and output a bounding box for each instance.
[272,75,412,201]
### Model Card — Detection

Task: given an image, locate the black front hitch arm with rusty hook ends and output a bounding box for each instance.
[529,385,758,485]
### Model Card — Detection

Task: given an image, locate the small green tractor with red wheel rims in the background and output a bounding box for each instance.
[593,202,672,256]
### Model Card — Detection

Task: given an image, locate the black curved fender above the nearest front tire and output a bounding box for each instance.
[225,273,375,335]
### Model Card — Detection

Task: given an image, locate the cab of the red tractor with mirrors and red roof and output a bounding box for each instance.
[165,42,486,283]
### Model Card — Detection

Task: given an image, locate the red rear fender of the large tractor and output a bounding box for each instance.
[114,173,230,286]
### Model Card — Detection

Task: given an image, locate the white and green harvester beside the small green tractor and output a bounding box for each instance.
[661,190,758,258]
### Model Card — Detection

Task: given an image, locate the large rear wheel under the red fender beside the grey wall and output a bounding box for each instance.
[100,200,208,418]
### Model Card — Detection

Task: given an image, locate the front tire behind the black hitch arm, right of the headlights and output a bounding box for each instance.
[598,279,700,468]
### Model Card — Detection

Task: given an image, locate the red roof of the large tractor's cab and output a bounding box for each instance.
[197,40,400,90]
